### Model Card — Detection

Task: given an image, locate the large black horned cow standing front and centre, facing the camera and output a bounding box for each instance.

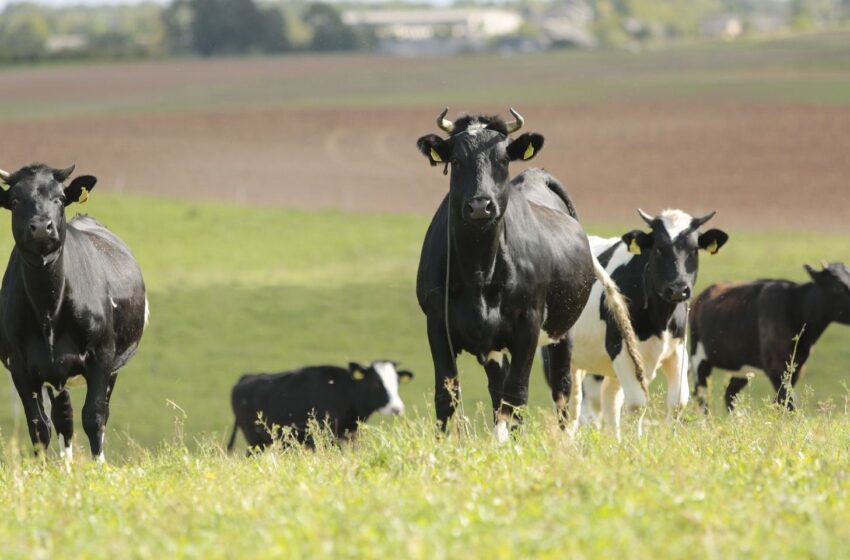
[416,109,640,441]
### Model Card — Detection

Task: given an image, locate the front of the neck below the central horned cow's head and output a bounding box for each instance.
[450,215,505,288]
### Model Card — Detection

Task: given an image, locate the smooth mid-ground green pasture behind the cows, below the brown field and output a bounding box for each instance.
[0,191,850,461]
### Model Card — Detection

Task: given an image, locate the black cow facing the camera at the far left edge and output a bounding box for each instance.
[0,164,148,462]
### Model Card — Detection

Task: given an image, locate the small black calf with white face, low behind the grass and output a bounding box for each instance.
[227,360,413,451]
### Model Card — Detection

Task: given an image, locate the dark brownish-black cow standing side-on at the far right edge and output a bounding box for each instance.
[691,263,850,410]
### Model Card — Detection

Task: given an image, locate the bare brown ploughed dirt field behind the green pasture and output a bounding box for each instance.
[3,104,850,231]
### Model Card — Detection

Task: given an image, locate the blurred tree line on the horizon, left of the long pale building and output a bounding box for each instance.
[0,0,374,63]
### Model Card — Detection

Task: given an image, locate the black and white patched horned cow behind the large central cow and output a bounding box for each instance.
[544,210,728,437]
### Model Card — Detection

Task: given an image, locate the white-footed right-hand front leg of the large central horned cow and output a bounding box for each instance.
[494,312,540,443]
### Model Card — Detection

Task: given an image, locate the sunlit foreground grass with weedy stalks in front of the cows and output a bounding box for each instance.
[0,403,850,560]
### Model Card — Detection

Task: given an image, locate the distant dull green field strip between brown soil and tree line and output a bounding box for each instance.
[0,32,850,121]
